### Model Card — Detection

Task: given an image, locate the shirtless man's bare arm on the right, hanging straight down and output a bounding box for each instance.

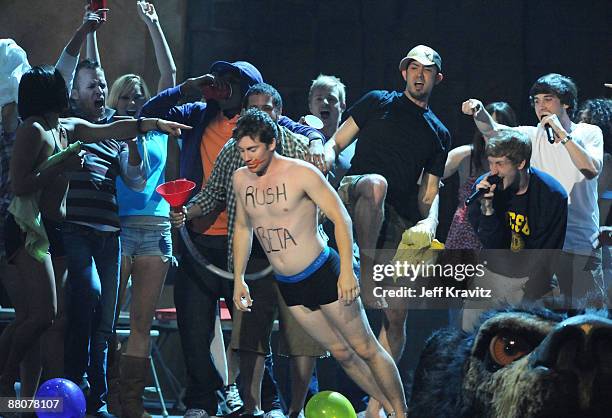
[299,163,359,303]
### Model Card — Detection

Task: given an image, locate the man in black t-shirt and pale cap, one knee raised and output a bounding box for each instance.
[325,45,450,414]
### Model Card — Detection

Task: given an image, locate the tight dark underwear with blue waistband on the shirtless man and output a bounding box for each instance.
[278,248,340,309]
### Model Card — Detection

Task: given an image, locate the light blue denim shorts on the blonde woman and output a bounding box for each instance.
[121,216,173,261]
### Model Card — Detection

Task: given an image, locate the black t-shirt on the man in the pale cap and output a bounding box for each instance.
[347,90,450,222]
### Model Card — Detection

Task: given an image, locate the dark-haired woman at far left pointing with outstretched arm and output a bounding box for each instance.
[0,65,185,396]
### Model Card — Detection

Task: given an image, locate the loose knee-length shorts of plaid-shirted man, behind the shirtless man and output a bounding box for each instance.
[230,276,329,357]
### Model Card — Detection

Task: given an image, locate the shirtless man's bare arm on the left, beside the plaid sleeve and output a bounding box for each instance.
[232,171,253,312]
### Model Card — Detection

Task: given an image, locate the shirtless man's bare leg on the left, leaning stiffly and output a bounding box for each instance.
[289,302,403,411]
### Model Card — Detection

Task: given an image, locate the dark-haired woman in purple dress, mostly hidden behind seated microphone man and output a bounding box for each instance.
[443,102,516,250]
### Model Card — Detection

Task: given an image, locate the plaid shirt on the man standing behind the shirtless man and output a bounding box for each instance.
[187,126,308,271]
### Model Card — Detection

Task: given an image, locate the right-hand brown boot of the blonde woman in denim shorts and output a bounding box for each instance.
[119,354,152,418]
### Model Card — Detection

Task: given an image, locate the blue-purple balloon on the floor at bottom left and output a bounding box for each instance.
[36,378,85,418]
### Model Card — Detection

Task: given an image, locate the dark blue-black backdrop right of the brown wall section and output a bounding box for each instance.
[183,0,612,240]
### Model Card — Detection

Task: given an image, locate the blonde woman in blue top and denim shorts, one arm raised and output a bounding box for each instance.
[88,1,178,418]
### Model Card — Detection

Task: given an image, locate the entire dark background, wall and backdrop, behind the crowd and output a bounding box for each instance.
[0,0,612,408]
